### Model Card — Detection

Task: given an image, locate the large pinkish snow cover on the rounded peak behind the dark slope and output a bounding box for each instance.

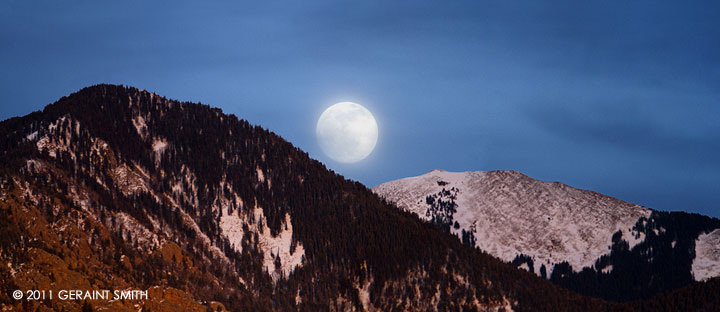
[373,170,651,274]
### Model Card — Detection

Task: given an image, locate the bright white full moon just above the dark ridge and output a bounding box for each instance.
[315,102,378,163]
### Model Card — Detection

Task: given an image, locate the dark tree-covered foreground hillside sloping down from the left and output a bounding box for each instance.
[0,85,718,311]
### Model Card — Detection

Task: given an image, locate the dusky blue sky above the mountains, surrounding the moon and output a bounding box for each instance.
[0,0,720,217]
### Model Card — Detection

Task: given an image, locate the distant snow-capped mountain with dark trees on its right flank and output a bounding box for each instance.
[373,170,720,301]
